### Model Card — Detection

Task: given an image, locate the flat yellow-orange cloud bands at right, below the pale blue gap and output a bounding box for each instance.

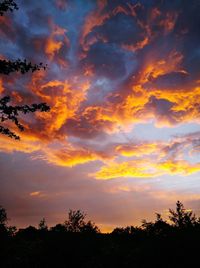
[91,133,200,180]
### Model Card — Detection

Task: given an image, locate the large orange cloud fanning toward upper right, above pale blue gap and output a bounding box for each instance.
[96,51,200,127]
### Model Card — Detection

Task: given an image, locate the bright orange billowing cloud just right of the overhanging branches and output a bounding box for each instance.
[26,69,90,137]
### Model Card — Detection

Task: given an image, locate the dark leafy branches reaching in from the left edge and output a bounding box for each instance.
[0,0,50,139]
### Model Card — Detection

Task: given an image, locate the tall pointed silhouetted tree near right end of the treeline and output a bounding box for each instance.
[169,201,198,228]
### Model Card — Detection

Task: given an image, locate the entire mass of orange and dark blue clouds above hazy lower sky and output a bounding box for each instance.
[0,0,200,177]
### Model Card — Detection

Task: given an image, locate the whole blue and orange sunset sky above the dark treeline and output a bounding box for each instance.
[0,0,200,231]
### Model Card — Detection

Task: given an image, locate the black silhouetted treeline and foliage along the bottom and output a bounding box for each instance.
[0,201,200,268]
